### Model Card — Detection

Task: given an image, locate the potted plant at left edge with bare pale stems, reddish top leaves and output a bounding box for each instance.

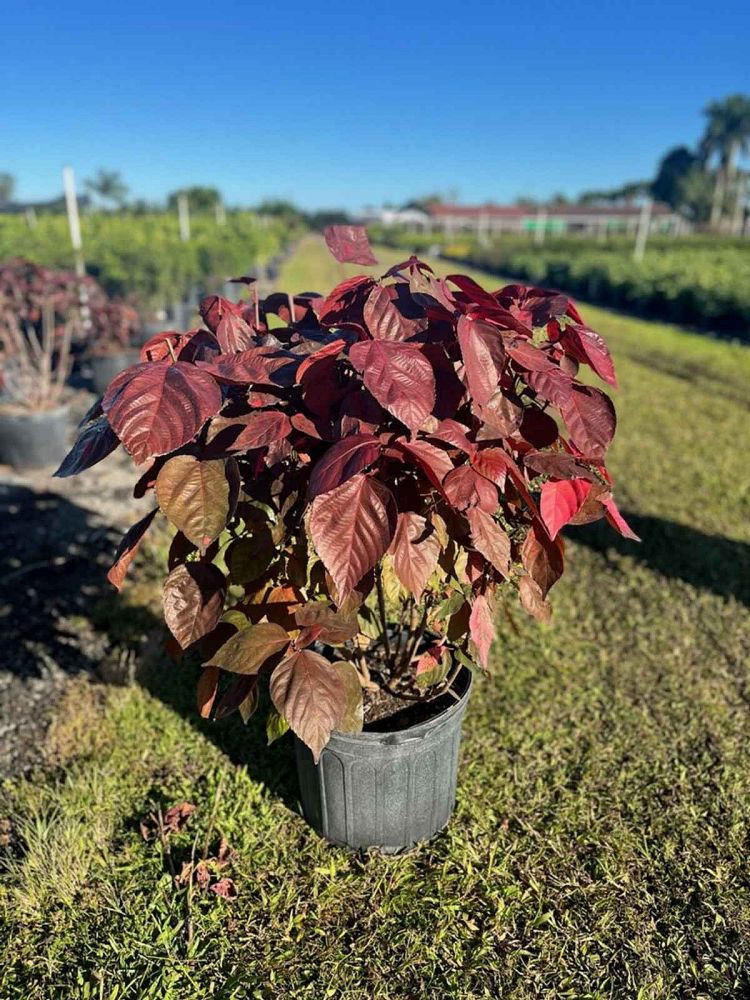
[0,260,80,469]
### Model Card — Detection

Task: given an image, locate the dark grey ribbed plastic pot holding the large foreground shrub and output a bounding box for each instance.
[294,668,471,854]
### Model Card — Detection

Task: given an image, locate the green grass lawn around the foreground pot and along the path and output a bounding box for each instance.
[0,240,750,1000]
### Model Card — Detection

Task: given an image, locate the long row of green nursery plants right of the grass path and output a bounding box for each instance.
[377,230,750,340]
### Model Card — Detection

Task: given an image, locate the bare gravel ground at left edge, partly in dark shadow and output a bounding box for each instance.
[0,390,153,777]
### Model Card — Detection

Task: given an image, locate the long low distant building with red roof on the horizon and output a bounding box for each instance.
[377,202,691,236]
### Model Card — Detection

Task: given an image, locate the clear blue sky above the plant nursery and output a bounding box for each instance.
[5,0,750,208]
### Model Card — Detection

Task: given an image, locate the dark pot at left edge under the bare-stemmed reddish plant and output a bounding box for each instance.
[0,405,68,471]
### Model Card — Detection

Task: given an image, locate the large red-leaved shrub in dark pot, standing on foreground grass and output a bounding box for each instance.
[55,227,632,851]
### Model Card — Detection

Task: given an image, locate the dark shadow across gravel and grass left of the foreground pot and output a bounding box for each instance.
[0,483,297,809]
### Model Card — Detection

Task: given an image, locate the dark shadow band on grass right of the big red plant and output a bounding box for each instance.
[566,511,750,606]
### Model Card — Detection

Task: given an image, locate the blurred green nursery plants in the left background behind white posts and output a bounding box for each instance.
[0,212,290,306]
